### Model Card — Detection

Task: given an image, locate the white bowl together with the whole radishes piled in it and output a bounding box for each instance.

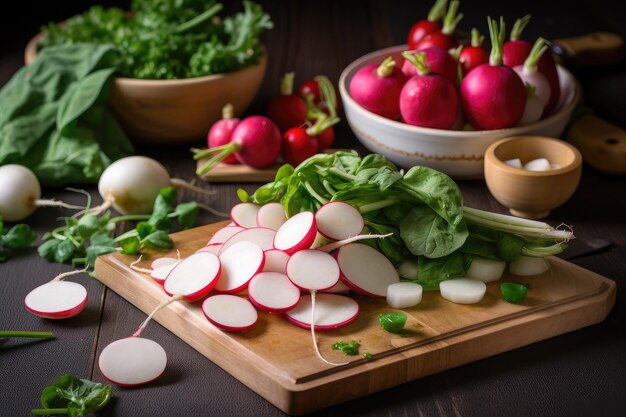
[339,13,580,179]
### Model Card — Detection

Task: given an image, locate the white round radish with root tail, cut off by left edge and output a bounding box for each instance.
[0,164,84,222]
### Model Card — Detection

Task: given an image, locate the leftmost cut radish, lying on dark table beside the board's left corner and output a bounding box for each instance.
[24,281,87,319]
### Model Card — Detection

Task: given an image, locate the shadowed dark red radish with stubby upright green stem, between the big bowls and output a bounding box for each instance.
[265,72,307,132]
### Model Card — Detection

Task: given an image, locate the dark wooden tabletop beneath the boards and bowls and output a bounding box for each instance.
[0,0,626,417]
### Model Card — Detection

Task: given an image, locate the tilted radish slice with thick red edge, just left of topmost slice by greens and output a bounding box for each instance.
[274,211,317,255]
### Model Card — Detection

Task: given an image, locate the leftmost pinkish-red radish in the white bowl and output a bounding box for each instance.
[350,57,407,119]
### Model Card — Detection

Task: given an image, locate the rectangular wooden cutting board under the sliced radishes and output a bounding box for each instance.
[95,222,615,415]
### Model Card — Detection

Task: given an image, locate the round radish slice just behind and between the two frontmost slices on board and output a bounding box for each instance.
[248,272,300,313]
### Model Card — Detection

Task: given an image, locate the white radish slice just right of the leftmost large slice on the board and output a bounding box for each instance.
[215,242,265,293]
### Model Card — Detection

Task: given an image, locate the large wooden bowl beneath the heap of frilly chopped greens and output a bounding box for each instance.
[24,33,267,145]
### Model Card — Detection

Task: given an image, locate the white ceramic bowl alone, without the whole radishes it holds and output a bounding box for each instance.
[339,45,580,179]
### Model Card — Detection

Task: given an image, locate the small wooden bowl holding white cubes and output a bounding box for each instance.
[484,136,582,219]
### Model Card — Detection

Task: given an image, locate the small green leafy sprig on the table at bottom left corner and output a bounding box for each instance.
[32,375,111,417]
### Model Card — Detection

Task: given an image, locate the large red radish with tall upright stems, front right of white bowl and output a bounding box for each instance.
[460,17,526,130]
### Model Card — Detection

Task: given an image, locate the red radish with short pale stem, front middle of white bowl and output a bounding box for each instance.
[400,52,458,129]
